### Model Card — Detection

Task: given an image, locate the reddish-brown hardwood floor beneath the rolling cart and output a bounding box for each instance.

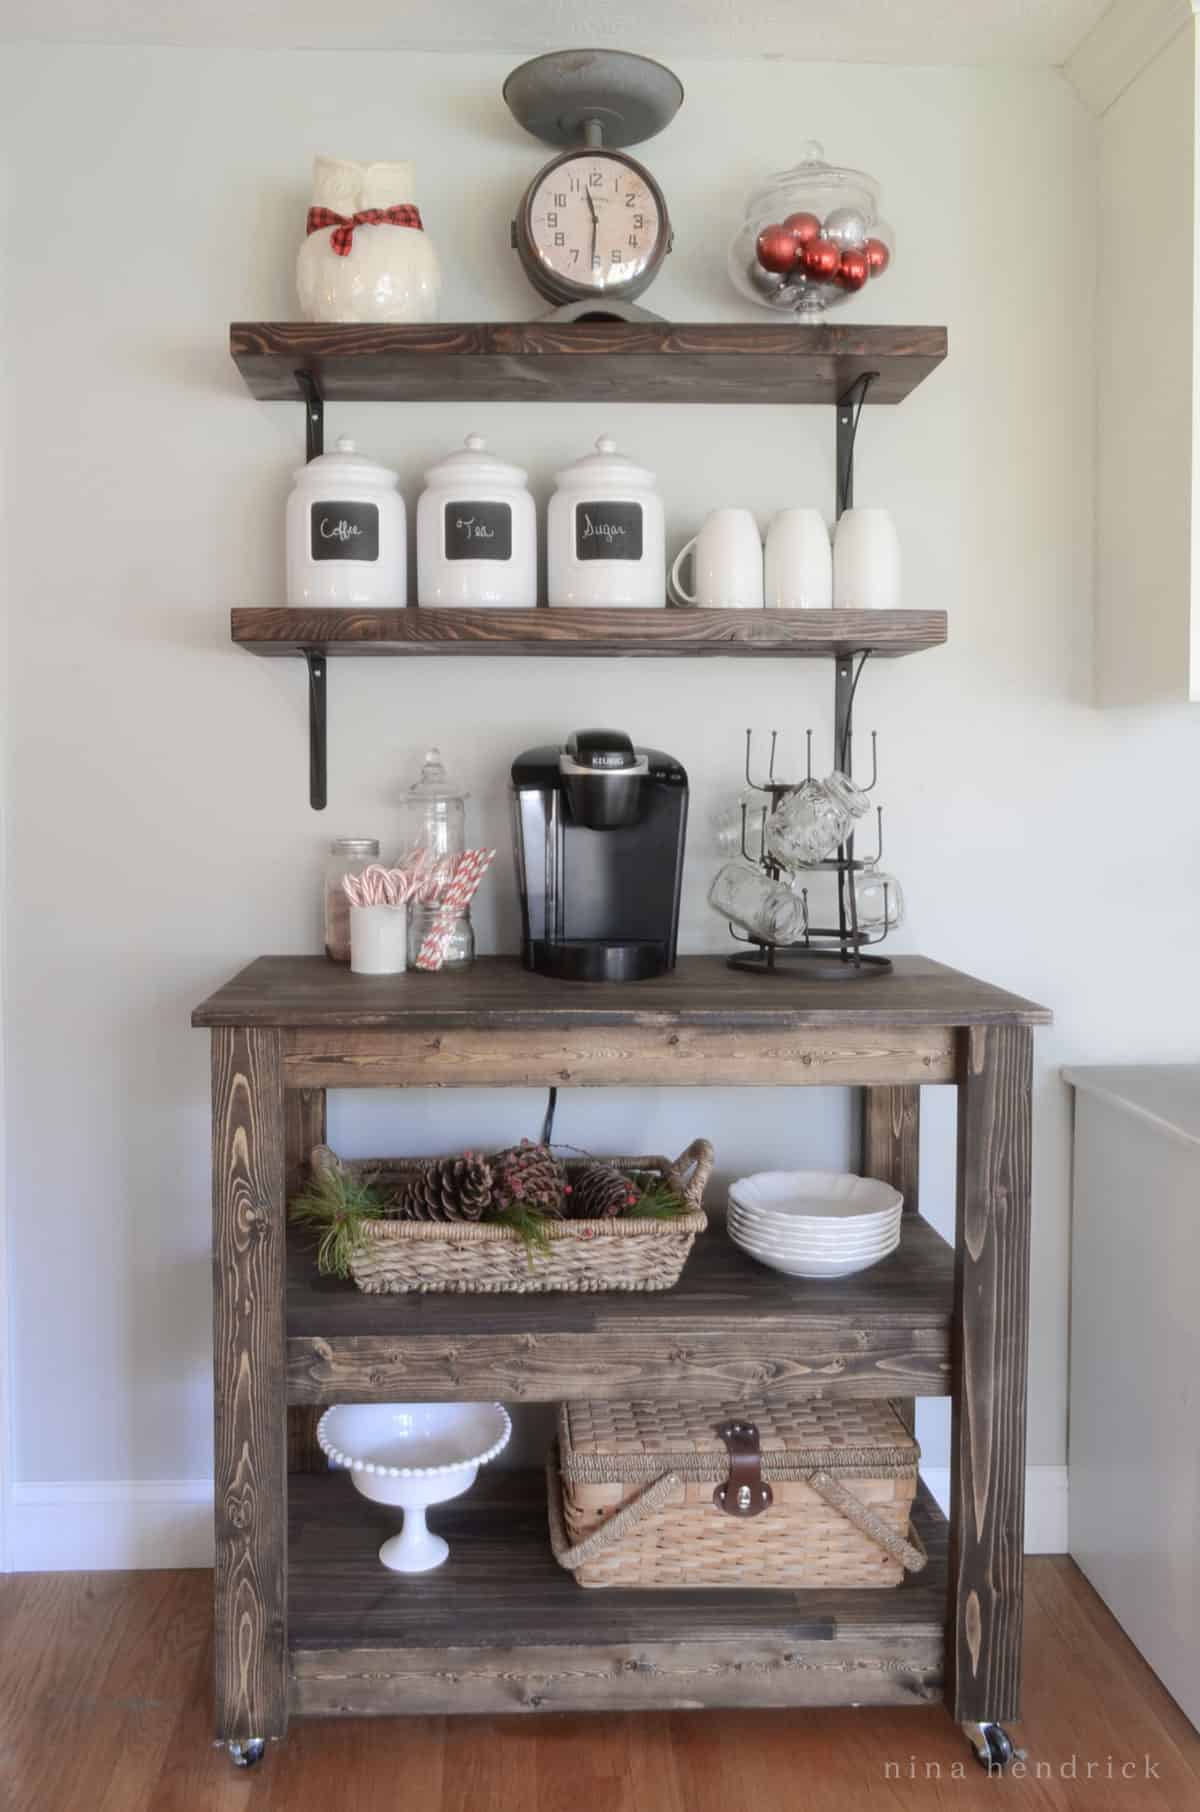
[0,1558,1200,1812]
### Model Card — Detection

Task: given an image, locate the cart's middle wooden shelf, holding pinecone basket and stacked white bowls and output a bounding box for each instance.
[286,1214,953,1402]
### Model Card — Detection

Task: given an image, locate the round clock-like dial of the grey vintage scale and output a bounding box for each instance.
[517,150,671,303]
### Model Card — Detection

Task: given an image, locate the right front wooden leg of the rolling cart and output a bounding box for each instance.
[946,1026,1033,1725]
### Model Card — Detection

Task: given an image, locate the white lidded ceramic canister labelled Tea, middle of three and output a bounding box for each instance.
[417,435,538,605]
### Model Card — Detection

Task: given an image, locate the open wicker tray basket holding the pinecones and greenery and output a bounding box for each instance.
[312,1138,712,1296]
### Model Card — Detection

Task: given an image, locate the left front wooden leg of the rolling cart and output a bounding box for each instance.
[212,1026,288,1767]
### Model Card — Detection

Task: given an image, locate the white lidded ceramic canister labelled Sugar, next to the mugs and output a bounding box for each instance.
[546,435,667,605]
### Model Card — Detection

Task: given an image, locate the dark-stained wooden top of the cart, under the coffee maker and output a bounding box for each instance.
[192,955,1051,1031]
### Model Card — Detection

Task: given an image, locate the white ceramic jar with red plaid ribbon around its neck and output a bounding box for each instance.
[295,158,442,323]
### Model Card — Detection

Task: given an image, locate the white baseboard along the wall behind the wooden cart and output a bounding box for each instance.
[11,1466,1068,1573]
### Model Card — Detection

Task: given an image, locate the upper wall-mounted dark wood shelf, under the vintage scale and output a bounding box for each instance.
[230,321,946,404]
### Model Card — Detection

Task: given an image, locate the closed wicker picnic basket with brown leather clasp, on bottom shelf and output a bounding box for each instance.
[547,1397,924,1587]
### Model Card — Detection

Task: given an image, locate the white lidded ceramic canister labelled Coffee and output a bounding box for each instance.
[286,435,408,605]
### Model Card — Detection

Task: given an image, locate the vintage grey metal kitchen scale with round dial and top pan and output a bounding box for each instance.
[504,51,683,321]
